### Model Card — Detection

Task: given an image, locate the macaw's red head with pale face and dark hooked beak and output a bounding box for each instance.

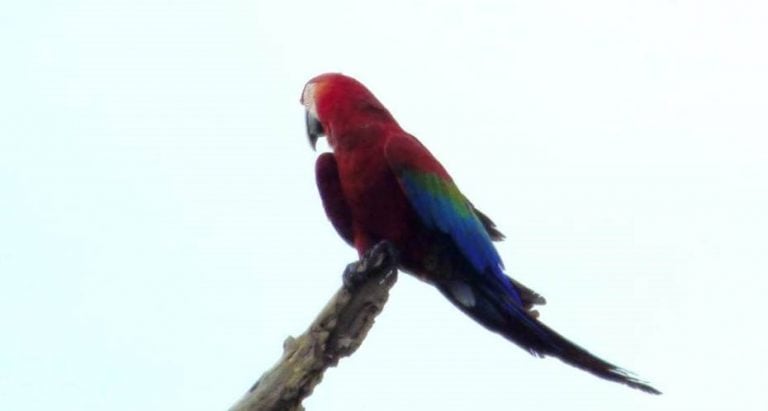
[301,73,397,149]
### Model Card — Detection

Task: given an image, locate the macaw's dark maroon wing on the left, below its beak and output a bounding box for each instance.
[315,153,354,245]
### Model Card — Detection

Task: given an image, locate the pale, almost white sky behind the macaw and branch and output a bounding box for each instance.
[0,0,768,411]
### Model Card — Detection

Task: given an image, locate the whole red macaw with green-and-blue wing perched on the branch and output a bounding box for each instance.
[301,73,660,394]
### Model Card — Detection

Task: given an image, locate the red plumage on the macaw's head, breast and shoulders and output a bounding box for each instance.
[305,74,436,271]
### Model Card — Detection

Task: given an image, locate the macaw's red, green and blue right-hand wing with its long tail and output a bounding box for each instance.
[385,135,659,394]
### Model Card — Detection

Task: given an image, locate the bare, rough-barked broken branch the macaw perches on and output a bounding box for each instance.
[230,243,397,411]
